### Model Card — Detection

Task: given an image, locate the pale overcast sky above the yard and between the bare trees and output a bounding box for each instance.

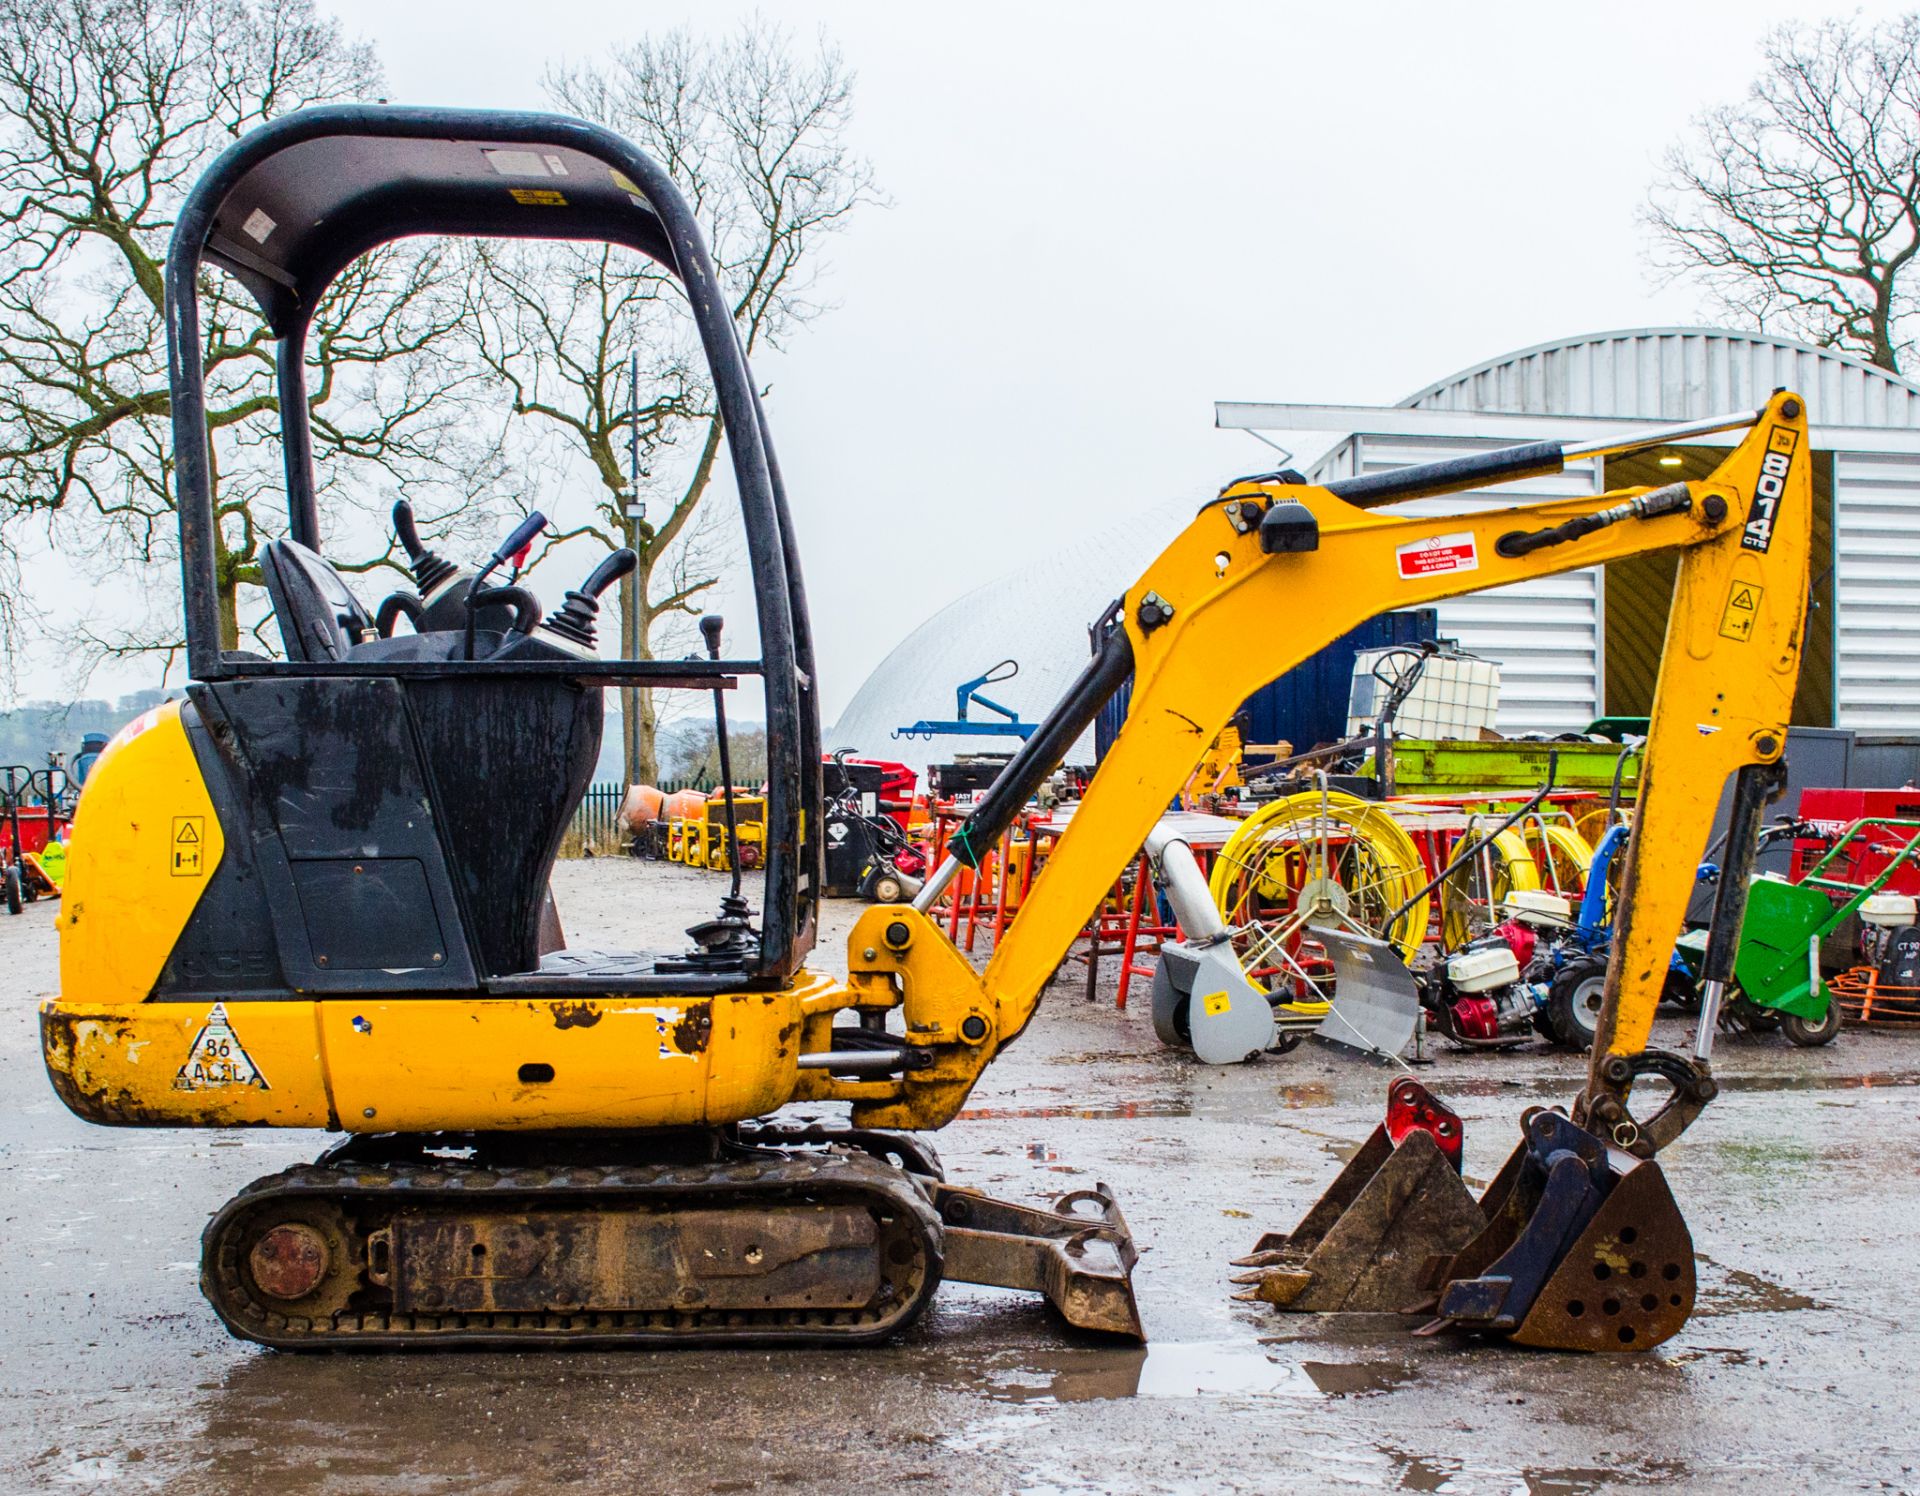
[15,0,1899,720]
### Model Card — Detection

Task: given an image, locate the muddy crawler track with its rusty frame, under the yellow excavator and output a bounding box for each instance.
[200,1148,943,1350]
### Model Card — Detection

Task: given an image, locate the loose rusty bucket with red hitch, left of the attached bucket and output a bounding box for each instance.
[1233,1079,1486,1314]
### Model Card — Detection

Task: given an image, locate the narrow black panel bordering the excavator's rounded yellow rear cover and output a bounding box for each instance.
[154,702,294,1002]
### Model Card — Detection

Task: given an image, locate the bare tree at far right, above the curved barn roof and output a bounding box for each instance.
[1647,15,1920,373]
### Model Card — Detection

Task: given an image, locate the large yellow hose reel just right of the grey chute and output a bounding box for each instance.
[1210,789,1430,995]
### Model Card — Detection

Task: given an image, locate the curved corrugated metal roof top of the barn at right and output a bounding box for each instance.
[1400,326,1920,426]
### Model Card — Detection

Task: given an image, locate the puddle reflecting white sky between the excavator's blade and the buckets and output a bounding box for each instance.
[960,1340,1415,1404]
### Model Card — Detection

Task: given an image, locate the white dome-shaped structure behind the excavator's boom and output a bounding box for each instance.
[826,499,1200,774]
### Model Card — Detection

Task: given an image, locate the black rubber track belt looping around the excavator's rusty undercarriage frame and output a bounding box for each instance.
[200,1148,941,1350]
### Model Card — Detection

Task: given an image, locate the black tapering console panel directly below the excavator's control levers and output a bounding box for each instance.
[405,676,605,977]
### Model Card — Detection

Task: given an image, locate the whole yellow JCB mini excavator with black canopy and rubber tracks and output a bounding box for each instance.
[40,106,1811,1348]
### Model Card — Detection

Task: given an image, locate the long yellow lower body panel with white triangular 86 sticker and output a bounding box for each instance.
[40,974,817,1131]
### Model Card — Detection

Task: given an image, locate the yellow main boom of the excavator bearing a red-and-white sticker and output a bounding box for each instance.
[833,396,1805,1127]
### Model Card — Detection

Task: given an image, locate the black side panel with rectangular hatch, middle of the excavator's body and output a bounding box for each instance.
[194,678,476,995]
